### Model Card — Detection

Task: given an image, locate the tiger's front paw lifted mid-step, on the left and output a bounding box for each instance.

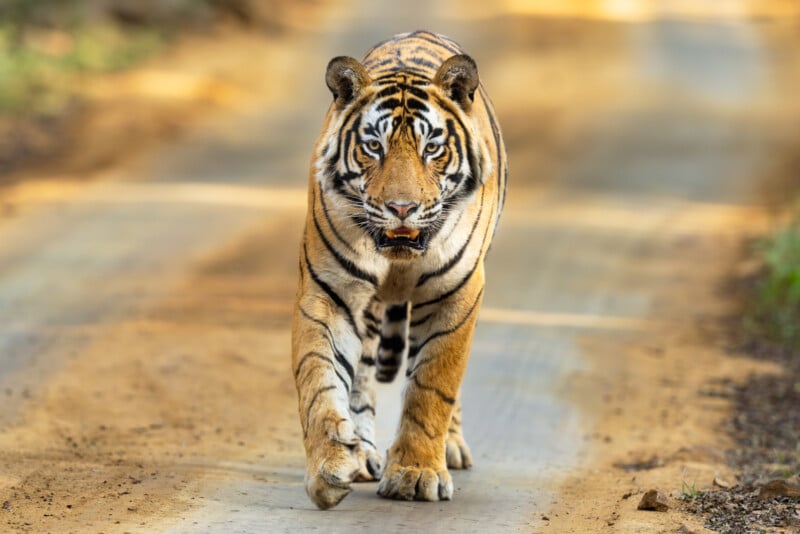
[305,420,359,510]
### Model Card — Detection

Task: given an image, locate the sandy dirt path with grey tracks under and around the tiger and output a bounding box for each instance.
[0,4,796,532]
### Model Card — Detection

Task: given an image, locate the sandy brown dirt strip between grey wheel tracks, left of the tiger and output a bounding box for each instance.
[0,219,303,532]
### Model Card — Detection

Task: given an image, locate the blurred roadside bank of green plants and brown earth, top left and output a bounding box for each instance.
[0,0,318,176]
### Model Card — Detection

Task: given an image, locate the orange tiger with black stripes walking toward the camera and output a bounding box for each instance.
[292,31,508,509]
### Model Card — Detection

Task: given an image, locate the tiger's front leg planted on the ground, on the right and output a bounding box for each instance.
[378,278,483,501]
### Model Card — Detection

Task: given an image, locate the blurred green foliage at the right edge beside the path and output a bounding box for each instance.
[747,215,800,350]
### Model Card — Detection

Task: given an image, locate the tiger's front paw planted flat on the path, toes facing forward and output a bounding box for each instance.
[378,464,453,501]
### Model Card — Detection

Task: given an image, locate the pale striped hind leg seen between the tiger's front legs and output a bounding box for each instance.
[350,298,384,482]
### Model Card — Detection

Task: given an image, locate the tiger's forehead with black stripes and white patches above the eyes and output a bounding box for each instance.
[361,72,444,137]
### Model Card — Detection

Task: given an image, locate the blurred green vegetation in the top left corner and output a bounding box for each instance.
[0,0,296,117]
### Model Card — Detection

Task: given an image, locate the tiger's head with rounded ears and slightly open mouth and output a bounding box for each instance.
[317,55,490,259]
